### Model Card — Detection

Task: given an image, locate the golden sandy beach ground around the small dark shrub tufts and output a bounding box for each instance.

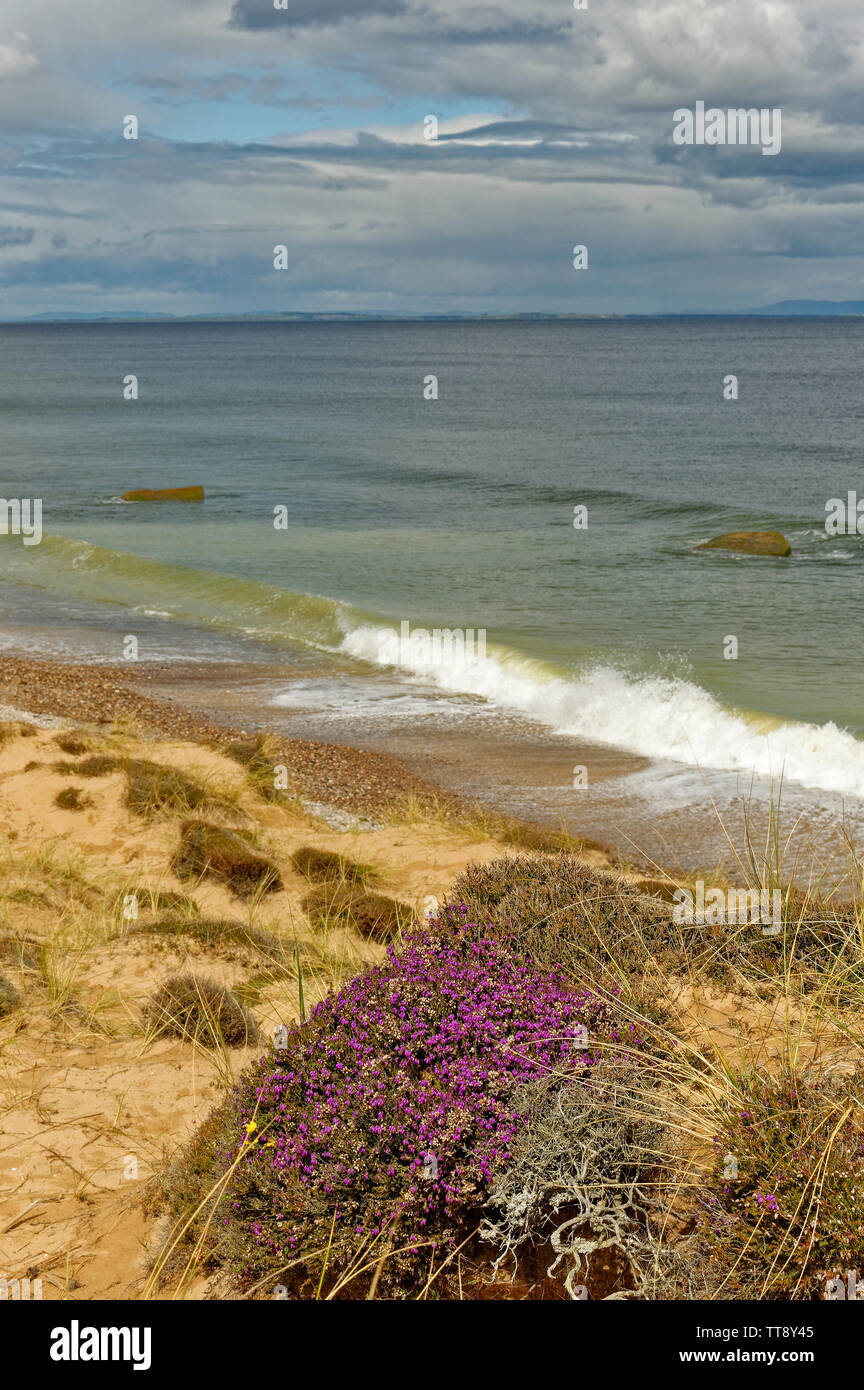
[0,659,513,1300]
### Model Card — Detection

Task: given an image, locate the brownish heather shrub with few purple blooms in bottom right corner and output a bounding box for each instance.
[693,1070,864,1300]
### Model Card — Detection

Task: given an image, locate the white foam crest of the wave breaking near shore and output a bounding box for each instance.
[342,627,864,798]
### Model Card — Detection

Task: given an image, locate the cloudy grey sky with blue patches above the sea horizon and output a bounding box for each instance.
[0,0,864,318]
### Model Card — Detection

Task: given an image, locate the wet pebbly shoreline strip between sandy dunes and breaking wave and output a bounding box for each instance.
[0,653,864,883]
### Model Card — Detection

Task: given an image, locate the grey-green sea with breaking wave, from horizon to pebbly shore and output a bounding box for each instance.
[0,317,864,873]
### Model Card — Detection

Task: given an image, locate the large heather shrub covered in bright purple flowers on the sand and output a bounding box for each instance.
[148,906,639,1294]
